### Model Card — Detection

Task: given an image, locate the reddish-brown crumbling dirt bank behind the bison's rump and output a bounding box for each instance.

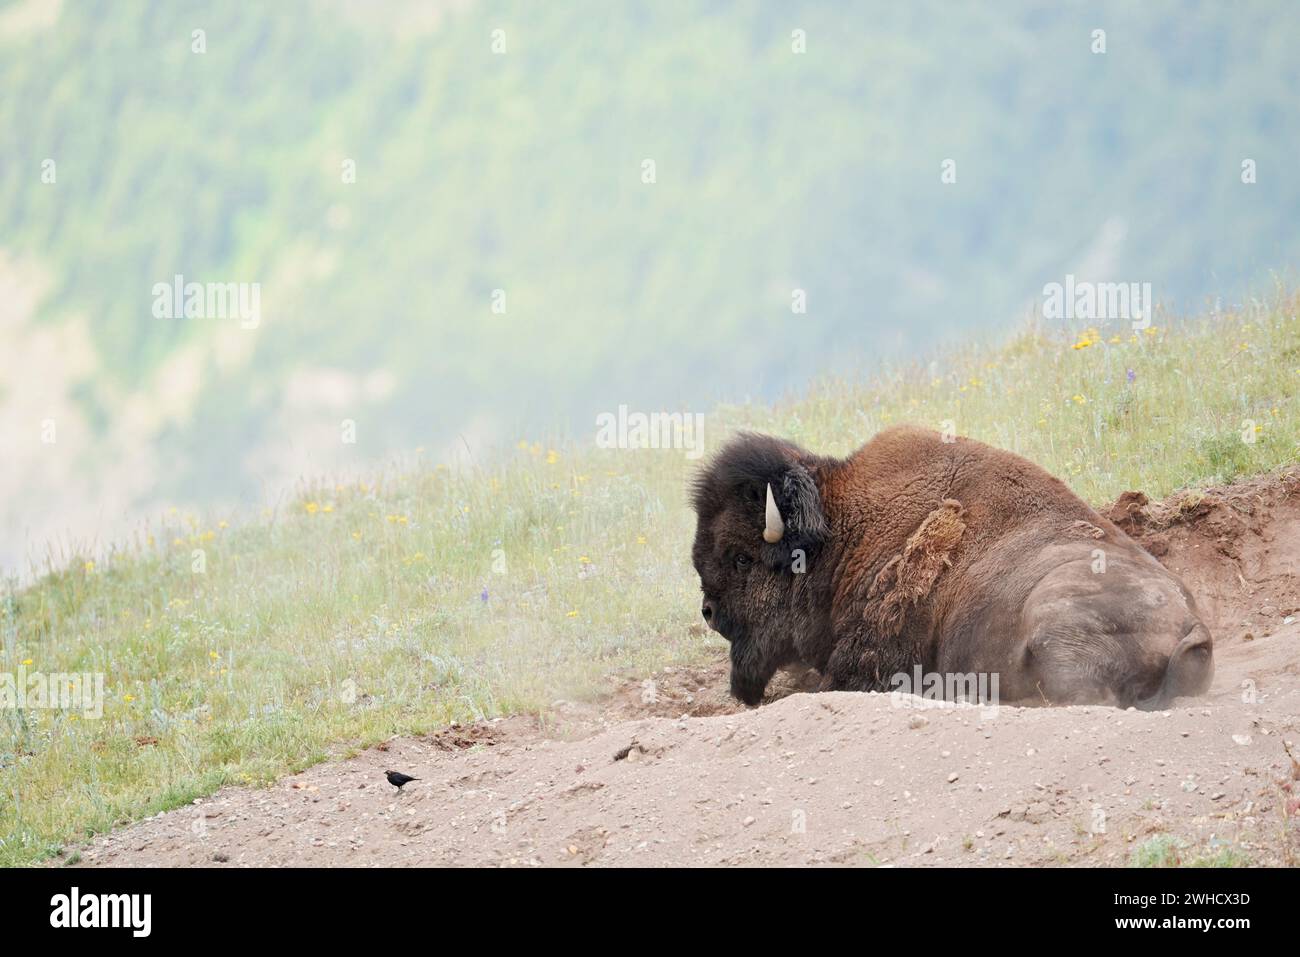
[1102,468,1300,644]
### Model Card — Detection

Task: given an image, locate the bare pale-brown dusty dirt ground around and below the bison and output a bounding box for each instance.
[73,471,1300,866]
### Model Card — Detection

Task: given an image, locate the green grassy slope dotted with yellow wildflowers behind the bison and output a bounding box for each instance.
[0,294,1300,865]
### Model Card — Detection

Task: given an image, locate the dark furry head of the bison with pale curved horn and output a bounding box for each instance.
[692,434,828,705]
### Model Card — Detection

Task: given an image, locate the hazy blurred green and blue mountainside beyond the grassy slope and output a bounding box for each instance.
[0,0,1300,570]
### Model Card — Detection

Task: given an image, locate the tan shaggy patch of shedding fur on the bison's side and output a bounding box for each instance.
[866,498,966,637]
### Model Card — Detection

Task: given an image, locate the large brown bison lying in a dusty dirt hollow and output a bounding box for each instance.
[692,426,1214,709]
